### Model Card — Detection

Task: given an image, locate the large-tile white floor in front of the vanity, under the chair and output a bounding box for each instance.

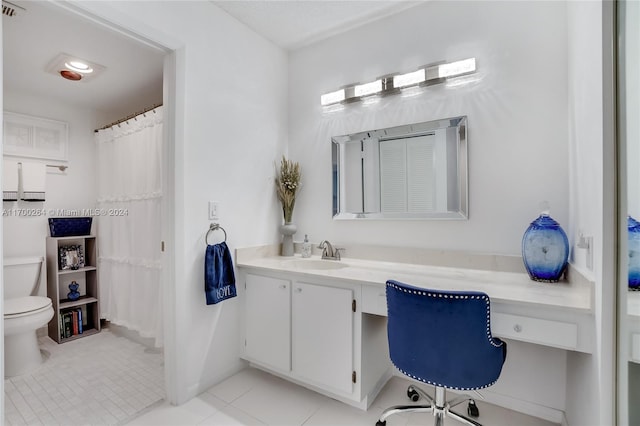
[127,368,554,426]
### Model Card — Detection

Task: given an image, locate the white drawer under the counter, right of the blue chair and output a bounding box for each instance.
[491,313,578,349]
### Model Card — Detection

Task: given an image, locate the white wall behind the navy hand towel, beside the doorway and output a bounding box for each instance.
[70,1,287,403]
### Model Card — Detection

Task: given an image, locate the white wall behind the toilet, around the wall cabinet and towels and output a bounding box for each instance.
[3,88,97,296]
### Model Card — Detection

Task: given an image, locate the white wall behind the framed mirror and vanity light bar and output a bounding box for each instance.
[289,1,569,256]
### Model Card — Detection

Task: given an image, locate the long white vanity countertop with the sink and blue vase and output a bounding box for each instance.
[236,255,593,313]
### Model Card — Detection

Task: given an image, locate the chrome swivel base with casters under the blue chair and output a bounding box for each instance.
[376,386,482,426]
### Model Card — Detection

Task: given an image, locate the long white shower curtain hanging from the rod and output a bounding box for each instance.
[96,107,163,346]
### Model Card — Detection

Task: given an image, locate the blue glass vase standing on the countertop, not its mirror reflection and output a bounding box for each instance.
[522,213,569,283]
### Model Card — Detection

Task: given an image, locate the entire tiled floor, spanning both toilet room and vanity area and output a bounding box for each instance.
[4,329,553,426]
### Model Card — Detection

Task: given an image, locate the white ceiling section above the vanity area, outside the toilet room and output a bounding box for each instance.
[211,0,425,50]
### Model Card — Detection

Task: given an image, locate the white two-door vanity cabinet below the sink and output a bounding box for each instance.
[239,268,390,409]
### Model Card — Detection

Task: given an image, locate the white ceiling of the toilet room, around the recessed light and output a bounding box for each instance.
[2,0,165,116]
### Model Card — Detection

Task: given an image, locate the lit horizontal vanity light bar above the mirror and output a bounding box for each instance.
[320,58,476,106]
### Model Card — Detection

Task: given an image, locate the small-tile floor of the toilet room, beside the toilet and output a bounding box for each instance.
[4,329,164,426]
